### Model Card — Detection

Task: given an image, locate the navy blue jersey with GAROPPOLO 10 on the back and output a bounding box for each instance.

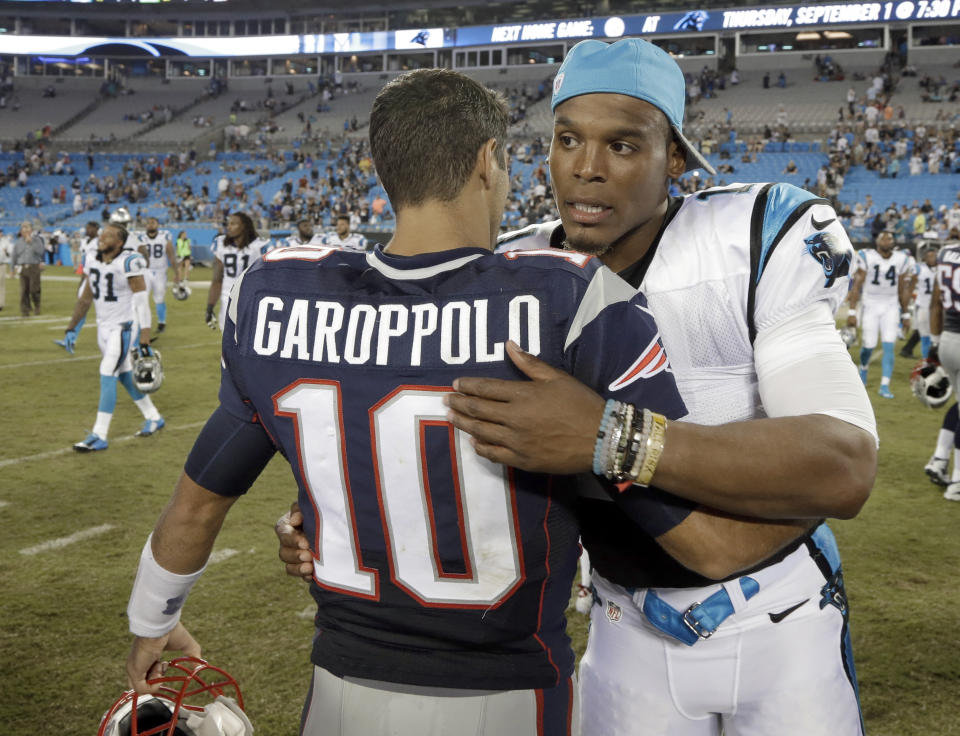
[201,246,685,689]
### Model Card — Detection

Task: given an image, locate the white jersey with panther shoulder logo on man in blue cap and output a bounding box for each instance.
[498,184,854,425]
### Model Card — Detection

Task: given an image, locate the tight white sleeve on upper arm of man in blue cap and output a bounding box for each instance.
[754,301,879,444]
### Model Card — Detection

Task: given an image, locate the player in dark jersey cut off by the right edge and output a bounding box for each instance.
[924,244,960,501]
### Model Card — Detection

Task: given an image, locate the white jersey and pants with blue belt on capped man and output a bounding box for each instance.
[500,184,876,736]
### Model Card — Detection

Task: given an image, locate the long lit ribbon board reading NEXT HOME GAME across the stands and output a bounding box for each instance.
[0,0,960,58]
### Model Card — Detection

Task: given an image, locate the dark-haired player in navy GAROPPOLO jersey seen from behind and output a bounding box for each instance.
[120,69,688,736]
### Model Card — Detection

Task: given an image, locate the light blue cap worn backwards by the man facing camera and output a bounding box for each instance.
[551,38,717,174]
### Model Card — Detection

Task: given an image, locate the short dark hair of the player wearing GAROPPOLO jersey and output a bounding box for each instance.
[370,69,508,210]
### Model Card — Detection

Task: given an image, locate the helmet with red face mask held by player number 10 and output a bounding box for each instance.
[97,657,253,736]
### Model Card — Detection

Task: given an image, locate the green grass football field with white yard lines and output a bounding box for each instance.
[0,268,960,736]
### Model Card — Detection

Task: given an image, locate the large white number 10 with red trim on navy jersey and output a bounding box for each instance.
[274,380,524,608]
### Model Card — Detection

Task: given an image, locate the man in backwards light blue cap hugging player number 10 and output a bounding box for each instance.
[442,39,877,736]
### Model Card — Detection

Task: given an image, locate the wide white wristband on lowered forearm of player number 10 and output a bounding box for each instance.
[127,534,207,639]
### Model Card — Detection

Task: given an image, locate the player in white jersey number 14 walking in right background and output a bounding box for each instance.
[847,230,913,399]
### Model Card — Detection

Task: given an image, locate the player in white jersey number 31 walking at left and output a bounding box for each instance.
[58,223,164,452]
